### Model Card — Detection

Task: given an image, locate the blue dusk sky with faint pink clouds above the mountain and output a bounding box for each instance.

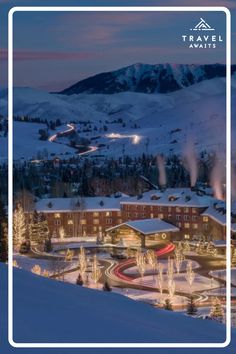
[0,0,236,91]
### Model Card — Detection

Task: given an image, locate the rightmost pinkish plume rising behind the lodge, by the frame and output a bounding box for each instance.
[210,157,225,200]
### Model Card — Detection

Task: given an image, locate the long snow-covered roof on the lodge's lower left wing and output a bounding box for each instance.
[35,197,125,213]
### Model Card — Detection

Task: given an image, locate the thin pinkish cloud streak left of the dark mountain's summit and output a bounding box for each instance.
[0,48,97,61]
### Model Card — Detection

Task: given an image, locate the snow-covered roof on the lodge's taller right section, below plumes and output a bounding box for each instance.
[121,188,215,208]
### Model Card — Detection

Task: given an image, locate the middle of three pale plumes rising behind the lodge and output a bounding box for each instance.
[183,141,198,188]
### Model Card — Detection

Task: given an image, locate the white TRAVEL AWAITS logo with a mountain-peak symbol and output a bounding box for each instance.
[181,17,223,50]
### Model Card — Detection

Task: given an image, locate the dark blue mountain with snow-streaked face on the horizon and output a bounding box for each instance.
[60,63,236,95]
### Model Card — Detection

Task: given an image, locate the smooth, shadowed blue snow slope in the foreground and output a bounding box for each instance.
[4,265,232,344]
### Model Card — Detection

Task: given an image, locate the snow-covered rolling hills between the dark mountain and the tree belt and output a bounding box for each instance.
[0,75,236,162]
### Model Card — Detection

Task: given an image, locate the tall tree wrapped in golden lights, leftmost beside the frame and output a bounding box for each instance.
[13,204,26,250]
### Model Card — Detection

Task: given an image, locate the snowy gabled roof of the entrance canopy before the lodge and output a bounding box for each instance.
[106,218,179,235]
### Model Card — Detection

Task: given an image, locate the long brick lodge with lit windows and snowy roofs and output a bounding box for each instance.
[35,188,233,240]
